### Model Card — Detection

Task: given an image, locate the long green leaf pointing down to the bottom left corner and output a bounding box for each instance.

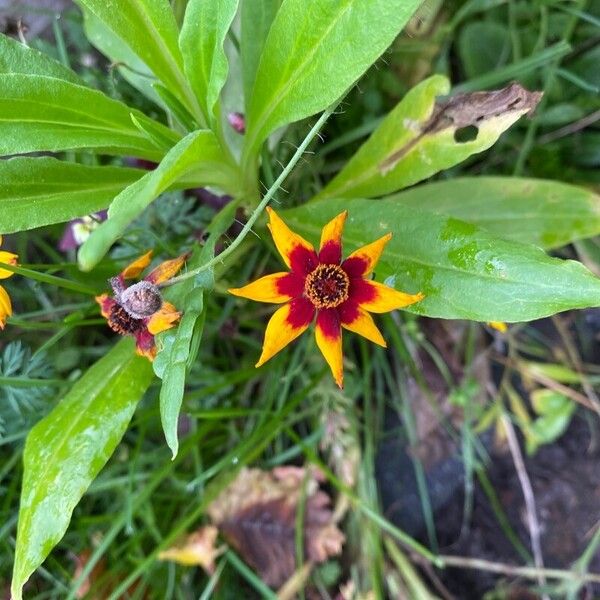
[12,339,152,600]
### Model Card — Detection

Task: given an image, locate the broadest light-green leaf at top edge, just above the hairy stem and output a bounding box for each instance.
[245,0,421,160]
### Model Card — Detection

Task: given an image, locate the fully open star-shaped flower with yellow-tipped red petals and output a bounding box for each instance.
[229,208,424,387]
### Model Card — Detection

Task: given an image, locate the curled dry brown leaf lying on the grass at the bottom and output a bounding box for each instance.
[208,467,344,587]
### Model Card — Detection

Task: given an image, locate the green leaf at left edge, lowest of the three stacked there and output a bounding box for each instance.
[0,157,146,233]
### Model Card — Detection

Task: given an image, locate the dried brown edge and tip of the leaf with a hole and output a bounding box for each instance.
[379,81,543,175]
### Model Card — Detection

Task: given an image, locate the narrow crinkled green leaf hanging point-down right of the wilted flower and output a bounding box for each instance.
[154,203,236,458]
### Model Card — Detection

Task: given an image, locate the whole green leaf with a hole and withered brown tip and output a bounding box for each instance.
[317,75,541,198]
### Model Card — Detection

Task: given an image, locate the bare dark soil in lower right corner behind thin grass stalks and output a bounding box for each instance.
[379,418,600,600]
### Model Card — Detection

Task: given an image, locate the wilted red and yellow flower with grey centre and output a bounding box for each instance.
[96,250,188,360]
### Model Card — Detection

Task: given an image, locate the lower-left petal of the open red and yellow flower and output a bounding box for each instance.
[256,298,315,367]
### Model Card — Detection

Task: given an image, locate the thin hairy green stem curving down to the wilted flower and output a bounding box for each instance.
[161,106,335,287]
